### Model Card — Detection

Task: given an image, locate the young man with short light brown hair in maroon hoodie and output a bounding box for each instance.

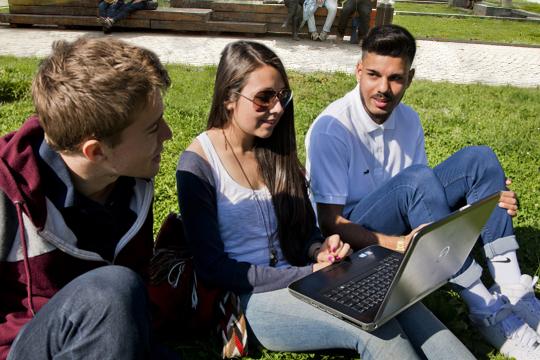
[0,38,171,359]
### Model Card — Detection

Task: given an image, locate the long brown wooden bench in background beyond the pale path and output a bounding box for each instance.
[0,0,376,35]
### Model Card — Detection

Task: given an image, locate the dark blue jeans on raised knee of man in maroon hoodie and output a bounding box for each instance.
[8,265,179,359]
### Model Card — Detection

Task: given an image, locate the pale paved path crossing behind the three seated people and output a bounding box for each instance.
[0,26,540,87]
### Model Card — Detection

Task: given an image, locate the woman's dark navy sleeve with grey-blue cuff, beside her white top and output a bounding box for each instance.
[176,151,312,294]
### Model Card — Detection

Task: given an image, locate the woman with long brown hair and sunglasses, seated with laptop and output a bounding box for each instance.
[176,41,470,359]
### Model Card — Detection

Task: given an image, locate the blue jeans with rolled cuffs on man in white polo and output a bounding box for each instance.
[346,146,518,289]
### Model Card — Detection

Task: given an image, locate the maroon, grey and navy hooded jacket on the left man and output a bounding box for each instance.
[0,117,154,360]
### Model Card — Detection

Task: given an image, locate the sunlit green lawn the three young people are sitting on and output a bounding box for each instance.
[0,57,540,360]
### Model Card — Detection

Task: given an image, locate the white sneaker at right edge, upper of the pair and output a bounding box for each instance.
[490,274,540,334]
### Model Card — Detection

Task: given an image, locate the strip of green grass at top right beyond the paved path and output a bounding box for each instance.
[393,14,540,45]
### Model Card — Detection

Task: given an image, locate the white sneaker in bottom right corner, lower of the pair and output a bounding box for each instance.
[469,304,540,360]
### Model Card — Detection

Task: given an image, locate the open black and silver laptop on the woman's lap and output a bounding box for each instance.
[289,192,500,331]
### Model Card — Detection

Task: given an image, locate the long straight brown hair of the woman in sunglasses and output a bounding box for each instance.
[207,41,315,265]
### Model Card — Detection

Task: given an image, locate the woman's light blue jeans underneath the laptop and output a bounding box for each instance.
[240,289,474,360]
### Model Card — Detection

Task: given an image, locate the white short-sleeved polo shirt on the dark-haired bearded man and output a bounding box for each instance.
[306,85,427,217]
